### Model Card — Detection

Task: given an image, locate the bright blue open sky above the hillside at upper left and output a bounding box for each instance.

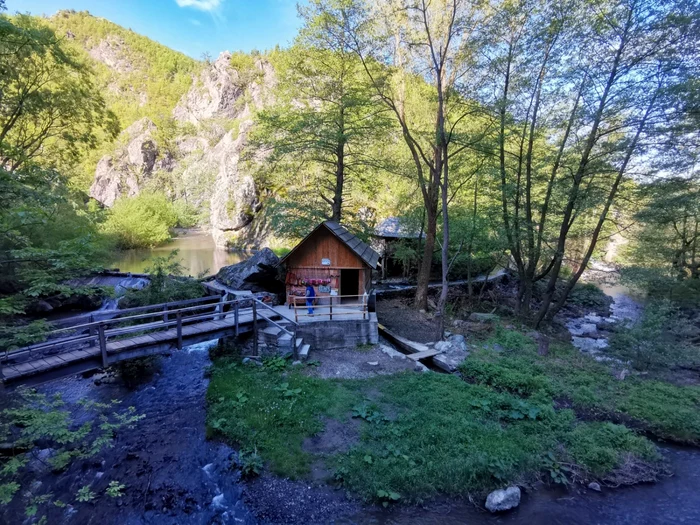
[6,0,300,58]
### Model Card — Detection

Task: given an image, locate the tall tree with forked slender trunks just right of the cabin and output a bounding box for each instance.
[311,0,486,319]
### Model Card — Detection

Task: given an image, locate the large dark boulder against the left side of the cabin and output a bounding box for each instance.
[216,248,284,293]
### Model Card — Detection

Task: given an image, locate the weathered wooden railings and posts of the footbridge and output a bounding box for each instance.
[0,296,297,366]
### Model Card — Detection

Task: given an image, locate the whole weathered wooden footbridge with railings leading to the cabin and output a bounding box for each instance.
[0,295,301,385]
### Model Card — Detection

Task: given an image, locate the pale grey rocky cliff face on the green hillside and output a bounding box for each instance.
[90,52,275,248]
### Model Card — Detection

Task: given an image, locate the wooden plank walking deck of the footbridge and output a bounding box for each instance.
[1,302,280,384]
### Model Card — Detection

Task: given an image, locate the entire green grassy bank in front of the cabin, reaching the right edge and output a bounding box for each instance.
[202,328,700,503]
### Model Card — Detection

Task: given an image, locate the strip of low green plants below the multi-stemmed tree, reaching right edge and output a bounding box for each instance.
[460,332,700,444]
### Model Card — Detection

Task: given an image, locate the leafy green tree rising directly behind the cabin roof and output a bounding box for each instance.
[253,41,388,233]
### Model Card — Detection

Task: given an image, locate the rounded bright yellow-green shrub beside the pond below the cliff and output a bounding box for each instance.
[104,193,178,248]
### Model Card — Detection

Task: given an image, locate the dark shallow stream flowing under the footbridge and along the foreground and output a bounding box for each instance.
[5,276,700,525]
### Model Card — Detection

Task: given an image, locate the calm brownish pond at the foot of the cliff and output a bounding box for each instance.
[110,230,247,277]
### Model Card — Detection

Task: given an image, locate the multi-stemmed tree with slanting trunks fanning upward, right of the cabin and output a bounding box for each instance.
[487,0,697,325]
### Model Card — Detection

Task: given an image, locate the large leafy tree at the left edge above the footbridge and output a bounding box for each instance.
[0,15,117,314]
